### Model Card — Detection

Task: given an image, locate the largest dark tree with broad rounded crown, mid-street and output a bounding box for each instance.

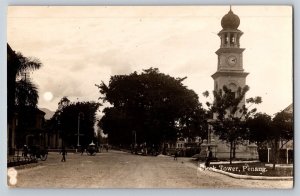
[96,68,204,145]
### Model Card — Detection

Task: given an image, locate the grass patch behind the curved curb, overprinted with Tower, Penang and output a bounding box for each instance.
[210,163,294,177]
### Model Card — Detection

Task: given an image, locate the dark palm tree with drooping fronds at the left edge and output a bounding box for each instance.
[7,44,42,148]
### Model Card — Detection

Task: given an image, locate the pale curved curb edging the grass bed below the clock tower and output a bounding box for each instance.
[198,164,294,180]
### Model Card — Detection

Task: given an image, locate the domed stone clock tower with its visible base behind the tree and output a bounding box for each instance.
[206,7,258,159]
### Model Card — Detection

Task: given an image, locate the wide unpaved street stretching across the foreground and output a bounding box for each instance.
[10,151,293,188]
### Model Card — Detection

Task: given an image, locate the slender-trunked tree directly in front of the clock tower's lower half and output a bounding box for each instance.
[203,85,261,164]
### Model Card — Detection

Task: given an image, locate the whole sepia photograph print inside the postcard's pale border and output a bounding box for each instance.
[5,5,295,189]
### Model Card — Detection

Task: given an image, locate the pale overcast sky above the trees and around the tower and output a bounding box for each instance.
[7,6,293,115]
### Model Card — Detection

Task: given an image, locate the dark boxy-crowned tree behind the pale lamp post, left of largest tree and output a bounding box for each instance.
[50,97,101,146]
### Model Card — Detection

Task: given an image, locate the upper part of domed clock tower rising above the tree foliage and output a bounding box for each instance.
[212,7,248,108]
